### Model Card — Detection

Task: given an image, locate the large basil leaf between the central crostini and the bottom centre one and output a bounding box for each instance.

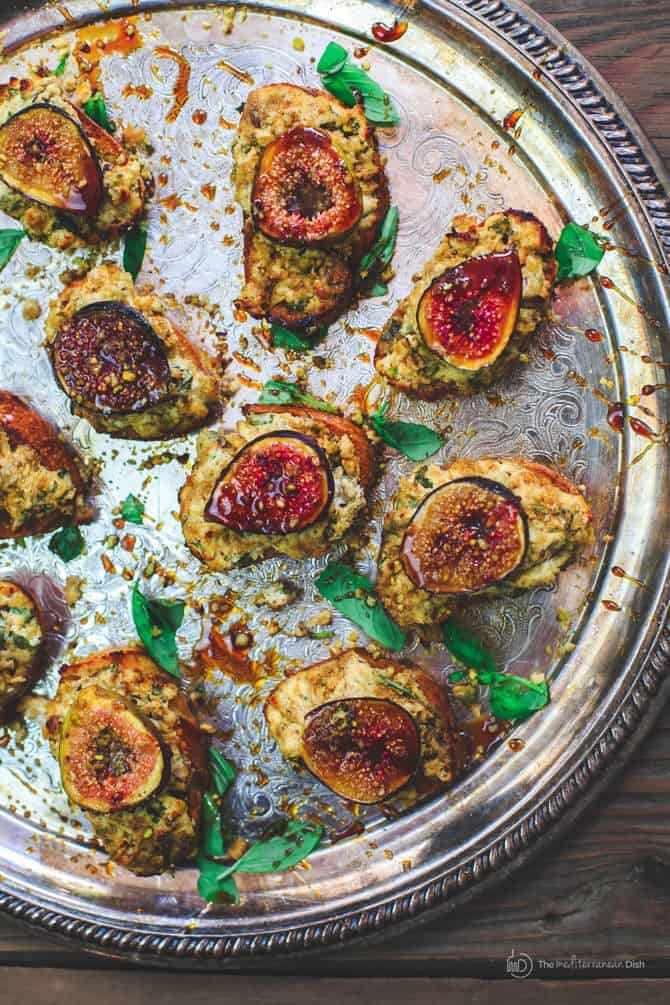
[316,563,405,652]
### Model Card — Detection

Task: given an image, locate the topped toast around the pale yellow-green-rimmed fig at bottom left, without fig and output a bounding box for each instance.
[44,647,209,875]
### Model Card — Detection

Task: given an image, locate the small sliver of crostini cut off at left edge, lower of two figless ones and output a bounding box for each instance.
[0,580,45,720]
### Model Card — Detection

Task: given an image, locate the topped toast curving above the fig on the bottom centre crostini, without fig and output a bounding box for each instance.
[264,648,459,792]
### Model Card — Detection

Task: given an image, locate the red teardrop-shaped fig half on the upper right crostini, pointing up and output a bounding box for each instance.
[417,249,522,370]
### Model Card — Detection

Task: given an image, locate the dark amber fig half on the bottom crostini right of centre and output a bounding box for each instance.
[301,697,420,803]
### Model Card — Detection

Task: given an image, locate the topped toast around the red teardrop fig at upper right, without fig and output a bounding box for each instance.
[375,209,556,400]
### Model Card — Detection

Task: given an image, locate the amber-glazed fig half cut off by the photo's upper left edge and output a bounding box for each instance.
[0,104,102,217]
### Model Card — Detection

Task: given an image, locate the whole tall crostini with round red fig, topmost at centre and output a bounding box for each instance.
[233,83,389,330]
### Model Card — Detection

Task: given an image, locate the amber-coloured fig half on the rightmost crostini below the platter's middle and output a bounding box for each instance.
[402,478,528,593]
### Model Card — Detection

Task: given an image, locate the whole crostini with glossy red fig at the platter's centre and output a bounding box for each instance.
[180,405,377,571]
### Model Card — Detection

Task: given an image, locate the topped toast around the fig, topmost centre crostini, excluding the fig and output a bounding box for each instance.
[233,83,389,329]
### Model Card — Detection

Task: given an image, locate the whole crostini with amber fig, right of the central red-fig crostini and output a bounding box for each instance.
[377,458,594,627]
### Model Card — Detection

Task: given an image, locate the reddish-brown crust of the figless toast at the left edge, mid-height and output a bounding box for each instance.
[0,390,92,539]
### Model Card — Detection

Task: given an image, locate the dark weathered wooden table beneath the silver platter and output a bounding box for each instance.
[0,0,670,1005]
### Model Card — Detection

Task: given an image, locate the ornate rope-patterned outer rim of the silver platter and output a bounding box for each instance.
[0,0,670,965]
